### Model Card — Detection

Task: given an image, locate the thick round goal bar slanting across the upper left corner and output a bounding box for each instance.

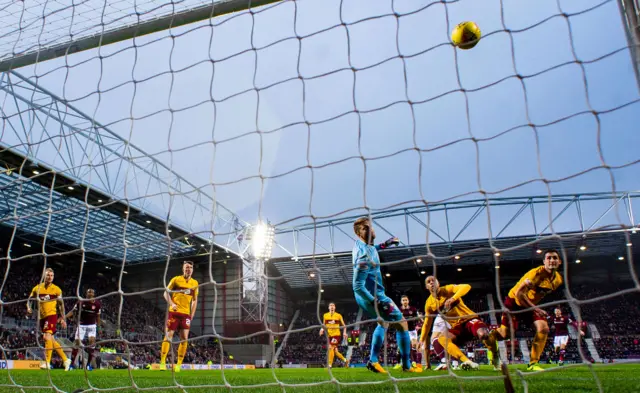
[0,0,282,72]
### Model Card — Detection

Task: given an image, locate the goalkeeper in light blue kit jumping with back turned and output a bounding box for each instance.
[352,217,422,374]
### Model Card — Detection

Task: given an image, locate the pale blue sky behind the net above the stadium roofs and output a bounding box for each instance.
[0,0,640,256]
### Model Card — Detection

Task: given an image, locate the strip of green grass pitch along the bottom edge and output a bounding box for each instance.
[0,364,640,393]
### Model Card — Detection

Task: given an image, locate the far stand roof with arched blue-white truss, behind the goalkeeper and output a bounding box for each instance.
[271,193,640,293]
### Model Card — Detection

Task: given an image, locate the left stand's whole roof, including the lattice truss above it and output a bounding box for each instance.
[0,72,247,263]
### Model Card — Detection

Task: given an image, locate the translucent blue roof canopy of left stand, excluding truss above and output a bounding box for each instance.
[0,150,224,262]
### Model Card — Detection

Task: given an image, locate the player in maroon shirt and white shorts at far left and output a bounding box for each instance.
[67,289,102,370]
